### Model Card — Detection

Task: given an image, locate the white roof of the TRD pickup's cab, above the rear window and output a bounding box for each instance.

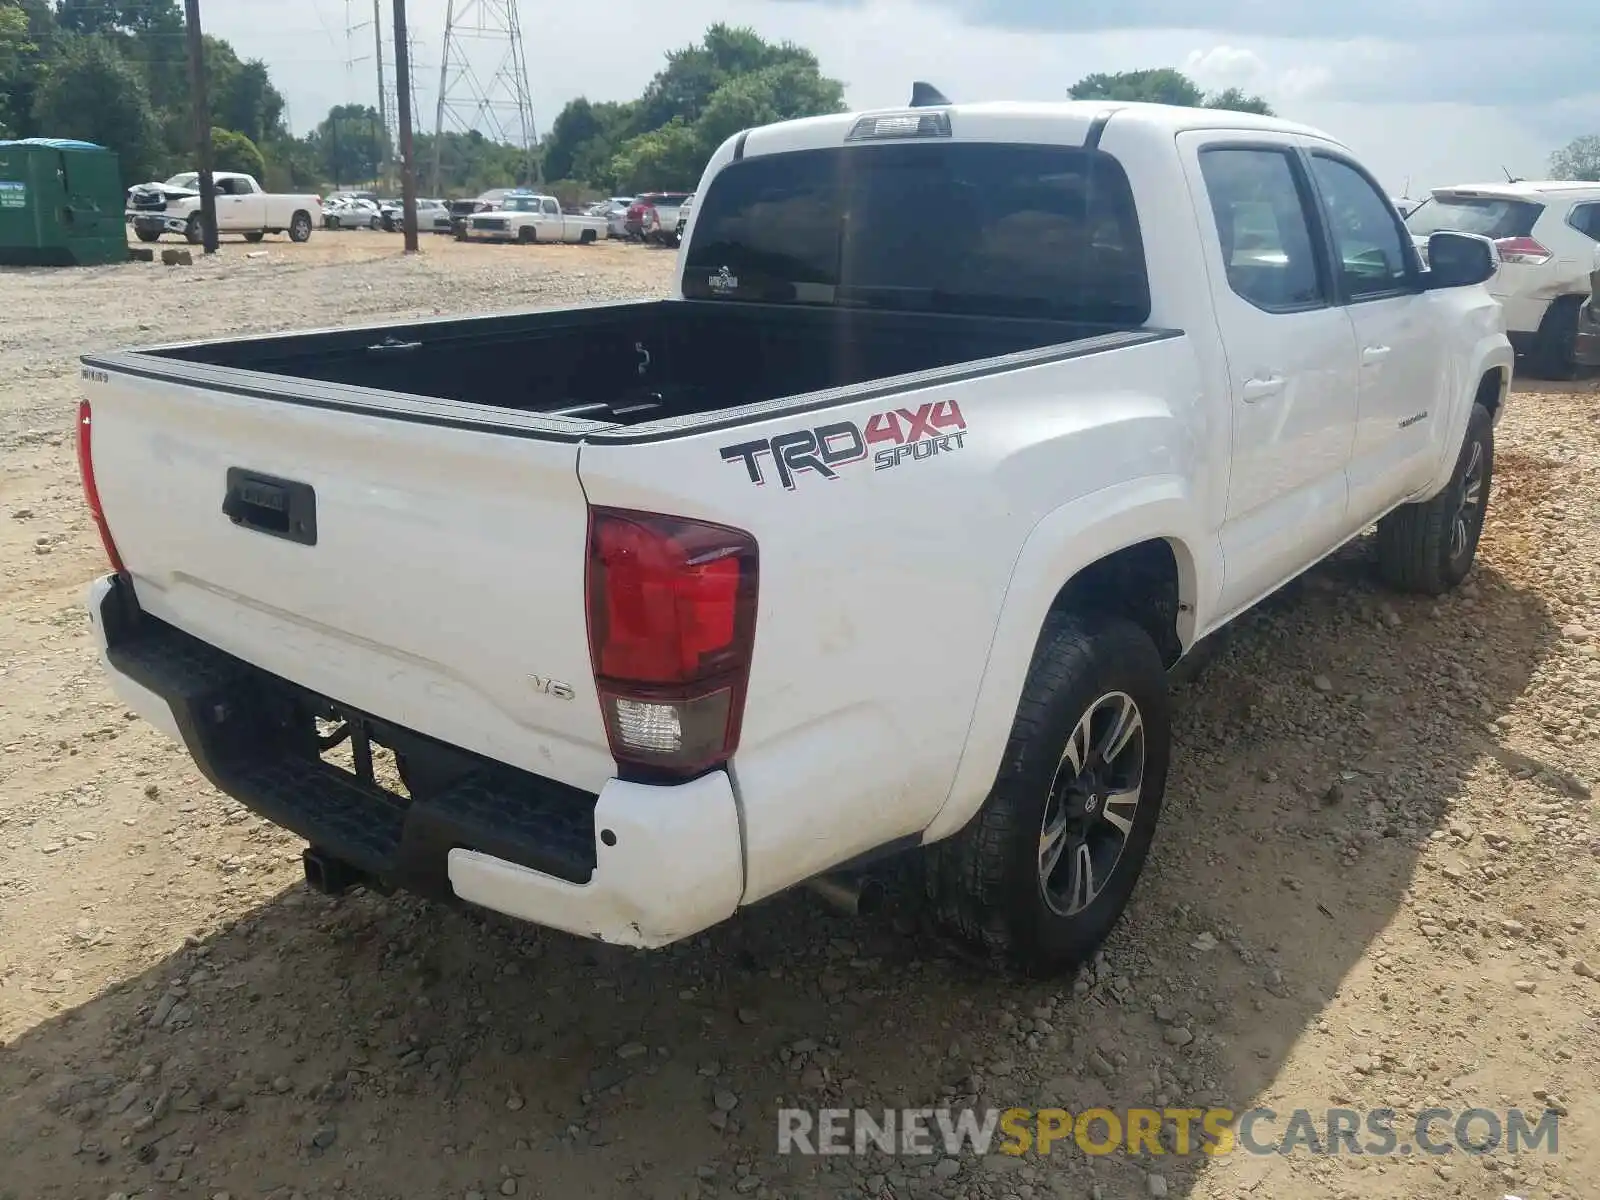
[741,101,1339,155]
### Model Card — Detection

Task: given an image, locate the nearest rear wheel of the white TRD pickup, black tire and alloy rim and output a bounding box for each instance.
[926,613,1171,976]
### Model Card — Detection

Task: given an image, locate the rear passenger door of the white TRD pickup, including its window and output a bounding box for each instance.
[1179,130,1357,614]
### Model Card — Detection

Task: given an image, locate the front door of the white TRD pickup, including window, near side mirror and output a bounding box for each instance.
[1307,141,1451,523]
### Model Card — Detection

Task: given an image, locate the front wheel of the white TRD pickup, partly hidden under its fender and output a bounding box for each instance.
[1378,403,1494,595]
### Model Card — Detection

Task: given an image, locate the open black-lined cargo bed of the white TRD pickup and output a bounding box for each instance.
[85,299,1165,437]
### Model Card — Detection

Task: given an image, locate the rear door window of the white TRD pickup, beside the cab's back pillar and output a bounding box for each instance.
[1200,146,1328,312]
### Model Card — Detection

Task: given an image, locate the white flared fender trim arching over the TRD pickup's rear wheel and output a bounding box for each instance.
[922,475,1221,842]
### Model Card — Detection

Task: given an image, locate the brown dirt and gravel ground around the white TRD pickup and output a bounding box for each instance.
[0,232,1600,1200]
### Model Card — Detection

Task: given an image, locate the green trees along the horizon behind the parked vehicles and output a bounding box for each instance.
[9,0,1600,200]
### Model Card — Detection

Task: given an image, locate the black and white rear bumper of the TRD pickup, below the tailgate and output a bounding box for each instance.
[88,576,744,947]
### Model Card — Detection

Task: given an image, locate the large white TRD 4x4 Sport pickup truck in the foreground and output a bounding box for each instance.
[78,102,1512,971]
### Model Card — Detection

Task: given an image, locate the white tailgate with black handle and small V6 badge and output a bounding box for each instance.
[90,374,616,792]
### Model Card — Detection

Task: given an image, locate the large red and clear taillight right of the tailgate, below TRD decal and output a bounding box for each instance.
[586,509,757,778]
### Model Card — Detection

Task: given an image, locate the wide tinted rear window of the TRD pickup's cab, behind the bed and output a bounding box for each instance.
[683,142,1150,325]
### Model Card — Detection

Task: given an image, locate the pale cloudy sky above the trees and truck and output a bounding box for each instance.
[202,0,1600,197]
